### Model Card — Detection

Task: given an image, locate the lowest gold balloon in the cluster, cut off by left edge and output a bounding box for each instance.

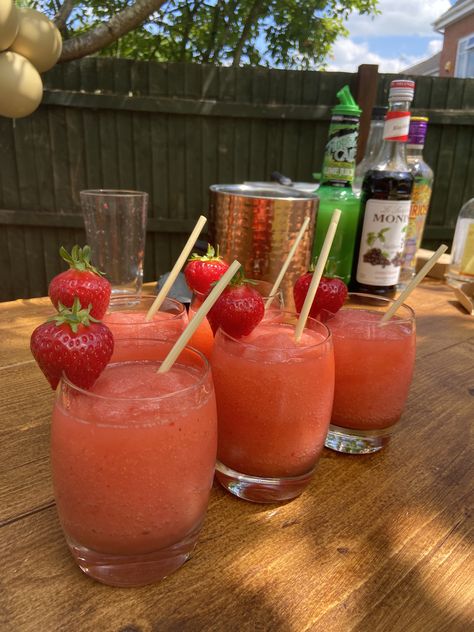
[0,51,43,118]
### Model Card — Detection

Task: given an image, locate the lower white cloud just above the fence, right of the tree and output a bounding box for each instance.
[327,38,443,72]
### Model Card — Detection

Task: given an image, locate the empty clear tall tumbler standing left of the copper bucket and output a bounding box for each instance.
[79,189,148,294]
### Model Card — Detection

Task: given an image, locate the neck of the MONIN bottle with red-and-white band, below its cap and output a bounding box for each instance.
[373,101,411,171]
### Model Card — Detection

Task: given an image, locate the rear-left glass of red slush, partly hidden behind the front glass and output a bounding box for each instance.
[102,294,188,362]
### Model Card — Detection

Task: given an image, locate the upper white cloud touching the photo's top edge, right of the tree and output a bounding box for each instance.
[346,0,451,37]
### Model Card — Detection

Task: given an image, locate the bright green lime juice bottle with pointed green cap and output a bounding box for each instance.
[312,86,361,284]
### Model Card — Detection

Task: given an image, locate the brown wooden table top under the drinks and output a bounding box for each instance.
[0,282,474,632]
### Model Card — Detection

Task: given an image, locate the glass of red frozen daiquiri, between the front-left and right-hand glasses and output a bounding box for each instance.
[211,312,334,502]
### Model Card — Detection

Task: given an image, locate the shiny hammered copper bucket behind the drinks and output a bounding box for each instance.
[209,184,319,310]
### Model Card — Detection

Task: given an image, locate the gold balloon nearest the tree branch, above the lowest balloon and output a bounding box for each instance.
[10,9,63,72]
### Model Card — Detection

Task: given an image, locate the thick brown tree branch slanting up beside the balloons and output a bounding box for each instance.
[59,0,167,61]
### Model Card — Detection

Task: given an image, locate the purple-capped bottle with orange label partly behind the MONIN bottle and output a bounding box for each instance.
[398,116,434,288]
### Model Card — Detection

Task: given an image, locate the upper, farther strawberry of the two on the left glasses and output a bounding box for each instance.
[48,246,111,320]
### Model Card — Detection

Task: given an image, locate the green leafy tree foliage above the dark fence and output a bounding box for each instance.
[29,0,378,70]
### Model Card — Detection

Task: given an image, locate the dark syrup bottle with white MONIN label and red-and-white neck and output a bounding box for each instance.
[352,79,415,296]
